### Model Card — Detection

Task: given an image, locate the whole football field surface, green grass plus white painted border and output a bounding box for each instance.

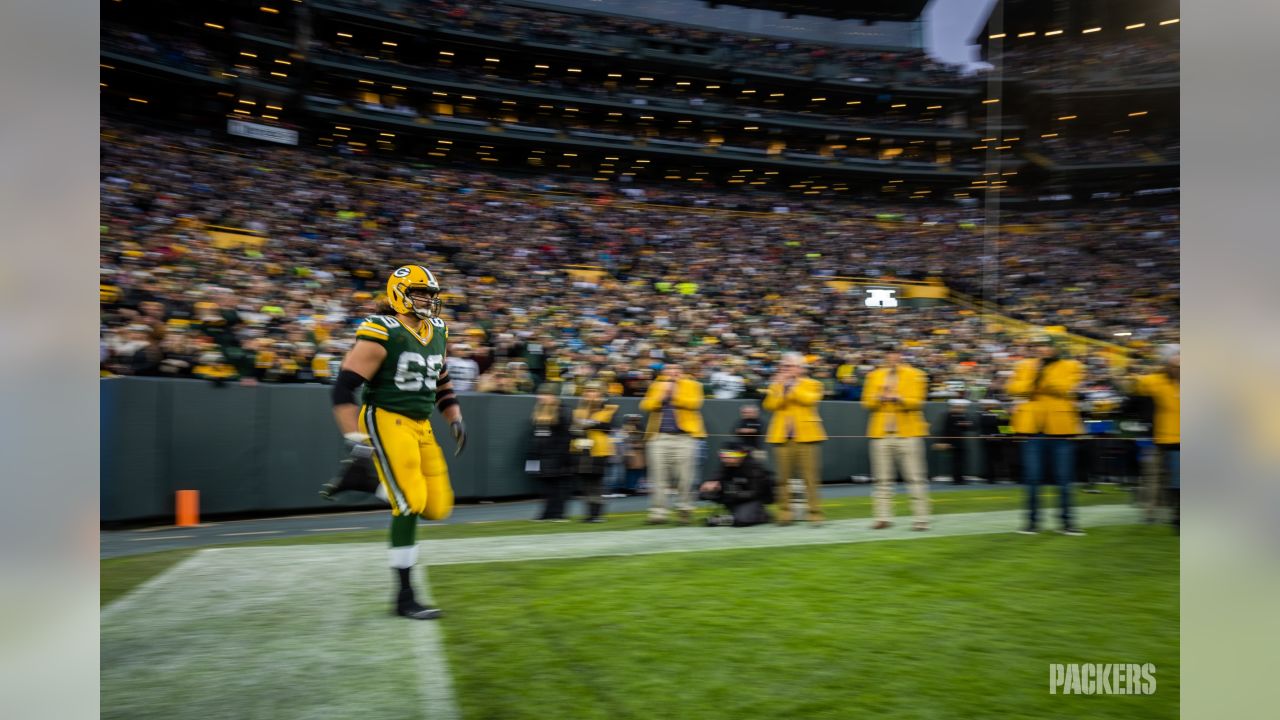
[102,488,1179,720]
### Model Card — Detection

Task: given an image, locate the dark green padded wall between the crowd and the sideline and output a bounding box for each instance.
[100,378,983,523]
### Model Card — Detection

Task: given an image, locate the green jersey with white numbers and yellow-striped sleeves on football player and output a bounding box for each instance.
[356,315,449,420]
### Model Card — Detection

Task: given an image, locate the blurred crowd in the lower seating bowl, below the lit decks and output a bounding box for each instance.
[101,126,1178,398]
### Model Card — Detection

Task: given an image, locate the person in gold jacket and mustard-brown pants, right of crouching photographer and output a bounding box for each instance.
[764,352,827,525]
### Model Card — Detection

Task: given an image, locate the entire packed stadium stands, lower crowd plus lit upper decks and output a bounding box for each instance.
[101,0,1179,398]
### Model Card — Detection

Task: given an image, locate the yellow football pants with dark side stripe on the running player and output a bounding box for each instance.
[360,405,453,520]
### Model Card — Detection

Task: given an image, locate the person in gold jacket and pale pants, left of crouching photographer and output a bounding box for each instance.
[640,363,707,525]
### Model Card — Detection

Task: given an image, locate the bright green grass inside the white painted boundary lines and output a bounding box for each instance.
[431,525,1179,720]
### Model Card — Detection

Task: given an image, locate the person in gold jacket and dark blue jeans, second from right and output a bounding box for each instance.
[1007,342,1084,536]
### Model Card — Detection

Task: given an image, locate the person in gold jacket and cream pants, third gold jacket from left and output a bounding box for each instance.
[863,347,929,530]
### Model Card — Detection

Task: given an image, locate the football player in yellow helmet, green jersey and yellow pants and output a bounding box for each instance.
[321,265,467,620]
